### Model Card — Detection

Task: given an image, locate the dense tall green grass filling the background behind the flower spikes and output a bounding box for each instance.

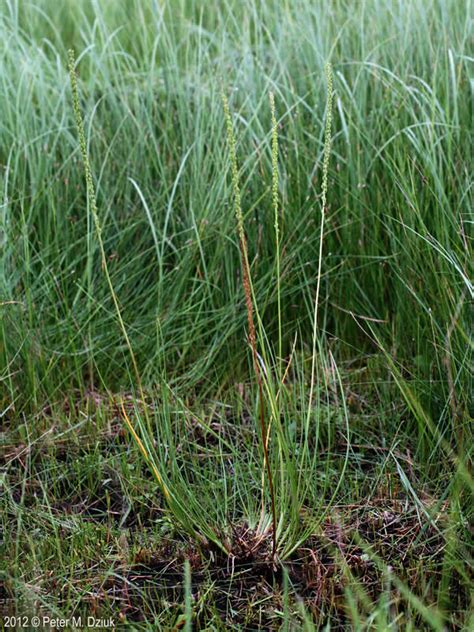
[1,1,471,449]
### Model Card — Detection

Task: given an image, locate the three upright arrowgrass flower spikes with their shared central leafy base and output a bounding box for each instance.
[221,64,349,559]
